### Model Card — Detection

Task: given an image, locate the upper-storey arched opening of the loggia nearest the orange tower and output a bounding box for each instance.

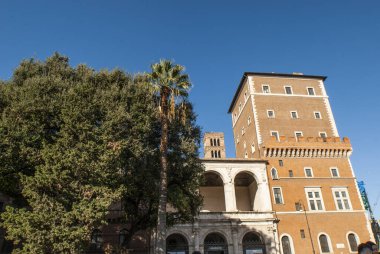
[234,172,257,211]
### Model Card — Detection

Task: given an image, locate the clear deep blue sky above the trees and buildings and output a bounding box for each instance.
[0,0,380,218]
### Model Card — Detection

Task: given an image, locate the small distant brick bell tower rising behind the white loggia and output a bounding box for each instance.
[203,132,226,159]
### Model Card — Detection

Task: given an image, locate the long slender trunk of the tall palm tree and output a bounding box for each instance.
[155,87,169,254]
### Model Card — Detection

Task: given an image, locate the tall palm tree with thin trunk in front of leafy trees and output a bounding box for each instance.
[149,60,191,254]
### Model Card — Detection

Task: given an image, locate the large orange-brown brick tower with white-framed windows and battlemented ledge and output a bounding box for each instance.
[229,72,374,253]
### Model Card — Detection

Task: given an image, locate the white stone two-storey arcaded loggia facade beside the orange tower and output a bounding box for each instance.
[167,159,280,254]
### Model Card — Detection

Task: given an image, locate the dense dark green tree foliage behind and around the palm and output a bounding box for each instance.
[0,54,203,253]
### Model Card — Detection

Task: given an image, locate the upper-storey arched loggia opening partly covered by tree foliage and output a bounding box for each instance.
[199,172,226,212]
